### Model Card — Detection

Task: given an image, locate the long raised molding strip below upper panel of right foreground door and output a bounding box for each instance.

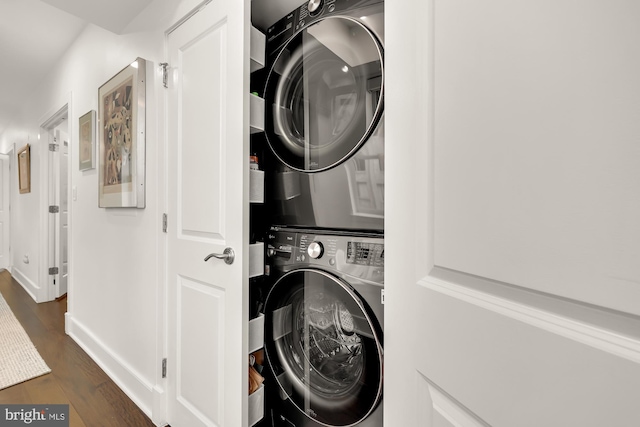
[418,276,640,363]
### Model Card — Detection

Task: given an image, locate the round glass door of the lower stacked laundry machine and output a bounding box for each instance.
[265,269,382,426]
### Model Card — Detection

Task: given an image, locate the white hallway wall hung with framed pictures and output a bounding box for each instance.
[0,0,208,424]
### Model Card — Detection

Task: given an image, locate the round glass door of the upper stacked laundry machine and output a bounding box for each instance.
[265,16,383,172]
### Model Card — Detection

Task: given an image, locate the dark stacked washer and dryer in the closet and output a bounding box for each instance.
[256,0,384,427]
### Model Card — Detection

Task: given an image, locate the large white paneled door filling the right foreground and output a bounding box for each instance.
[385,0,640,427]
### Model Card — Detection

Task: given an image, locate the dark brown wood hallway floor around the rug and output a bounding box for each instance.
[0,271,159,427]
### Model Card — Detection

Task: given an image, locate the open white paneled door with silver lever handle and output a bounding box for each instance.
[167,0,249,427]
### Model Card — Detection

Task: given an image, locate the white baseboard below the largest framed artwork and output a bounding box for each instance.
[65,313,164,425]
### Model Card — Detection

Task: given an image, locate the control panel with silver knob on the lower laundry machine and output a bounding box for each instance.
[267,228,384,283]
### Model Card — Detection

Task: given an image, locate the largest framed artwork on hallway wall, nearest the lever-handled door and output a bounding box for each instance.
[97,58,147,209]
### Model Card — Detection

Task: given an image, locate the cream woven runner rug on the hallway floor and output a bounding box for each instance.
[0,294,51,390]
